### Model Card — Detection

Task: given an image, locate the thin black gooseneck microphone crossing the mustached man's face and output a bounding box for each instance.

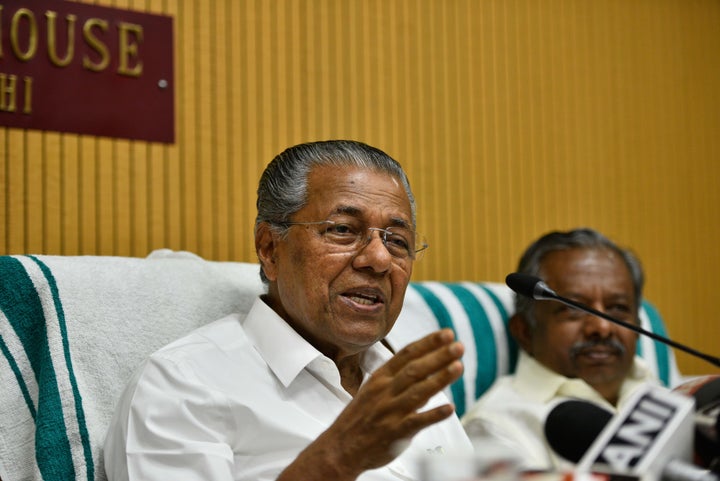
[505,272,720,367]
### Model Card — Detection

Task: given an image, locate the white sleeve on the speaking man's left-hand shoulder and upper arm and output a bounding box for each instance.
[104,358,235,481]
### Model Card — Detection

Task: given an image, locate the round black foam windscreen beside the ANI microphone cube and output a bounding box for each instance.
[545,399,613,463]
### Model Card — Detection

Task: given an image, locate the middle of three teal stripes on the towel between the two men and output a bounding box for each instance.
[446,284,498,404]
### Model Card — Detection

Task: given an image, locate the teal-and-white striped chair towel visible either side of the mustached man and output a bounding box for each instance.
[389,281,680,415]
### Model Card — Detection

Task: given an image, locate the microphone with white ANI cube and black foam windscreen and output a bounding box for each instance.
[545,384,718,481]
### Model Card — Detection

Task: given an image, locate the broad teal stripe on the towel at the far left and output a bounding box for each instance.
[0,256,75,480]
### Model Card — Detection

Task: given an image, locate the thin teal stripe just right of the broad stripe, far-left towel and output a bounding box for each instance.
[30,256,95,481]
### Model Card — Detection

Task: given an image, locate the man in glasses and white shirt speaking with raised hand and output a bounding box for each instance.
[104,141,472,481]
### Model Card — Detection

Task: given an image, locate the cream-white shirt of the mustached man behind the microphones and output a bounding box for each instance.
[462,351,657,470]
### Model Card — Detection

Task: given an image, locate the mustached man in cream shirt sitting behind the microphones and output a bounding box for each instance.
[463,228,656,470]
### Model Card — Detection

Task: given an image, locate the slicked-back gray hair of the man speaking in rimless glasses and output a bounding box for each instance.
[255,140,416,283]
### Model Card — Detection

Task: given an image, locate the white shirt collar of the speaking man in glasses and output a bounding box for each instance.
[242,297,392,387]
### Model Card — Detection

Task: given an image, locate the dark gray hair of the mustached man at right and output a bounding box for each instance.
[515,228,645,325]
